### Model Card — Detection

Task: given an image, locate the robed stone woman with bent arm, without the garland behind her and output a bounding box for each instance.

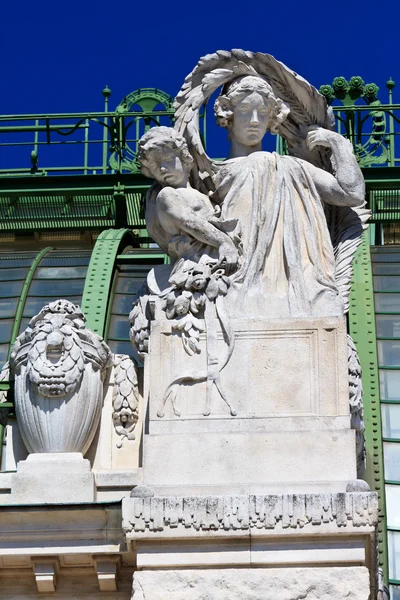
[212,75,364,317]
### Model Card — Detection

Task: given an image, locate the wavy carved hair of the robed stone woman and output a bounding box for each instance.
[214,75,290,133]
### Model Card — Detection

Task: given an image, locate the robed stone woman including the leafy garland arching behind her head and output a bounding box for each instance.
[175,51,365,317]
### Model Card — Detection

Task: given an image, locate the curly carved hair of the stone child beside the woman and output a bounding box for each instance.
[137,126,193,177]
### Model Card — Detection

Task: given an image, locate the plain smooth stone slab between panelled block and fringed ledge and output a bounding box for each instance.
[143,429,356,495]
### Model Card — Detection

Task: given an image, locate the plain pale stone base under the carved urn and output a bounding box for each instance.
[11,452,95,504]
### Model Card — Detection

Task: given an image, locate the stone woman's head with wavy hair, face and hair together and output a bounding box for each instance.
[214,75,290,146]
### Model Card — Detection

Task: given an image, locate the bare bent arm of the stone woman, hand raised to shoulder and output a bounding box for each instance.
[307,127,365,206]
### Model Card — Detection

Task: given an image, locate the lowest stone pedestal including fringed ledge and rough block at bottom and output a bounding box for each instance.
[122,492,378,600]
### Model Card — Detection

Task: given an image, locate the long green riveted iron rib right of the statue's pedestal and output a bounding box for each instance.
[349,231,388,581]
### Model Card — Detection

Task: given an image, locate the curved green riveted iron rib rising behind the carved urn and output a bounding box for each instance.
[82,229,136,337]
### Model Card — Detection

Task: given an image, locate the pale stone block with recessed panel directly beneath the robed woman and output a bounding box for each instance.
[150,317,349,422]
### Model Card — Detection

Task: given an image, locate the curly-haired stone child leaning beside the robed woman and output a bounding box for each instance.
[138,127,239,274]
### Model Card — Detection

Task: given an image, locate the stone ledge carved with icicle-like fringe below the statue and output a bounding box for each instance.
[122,492,378,539]
